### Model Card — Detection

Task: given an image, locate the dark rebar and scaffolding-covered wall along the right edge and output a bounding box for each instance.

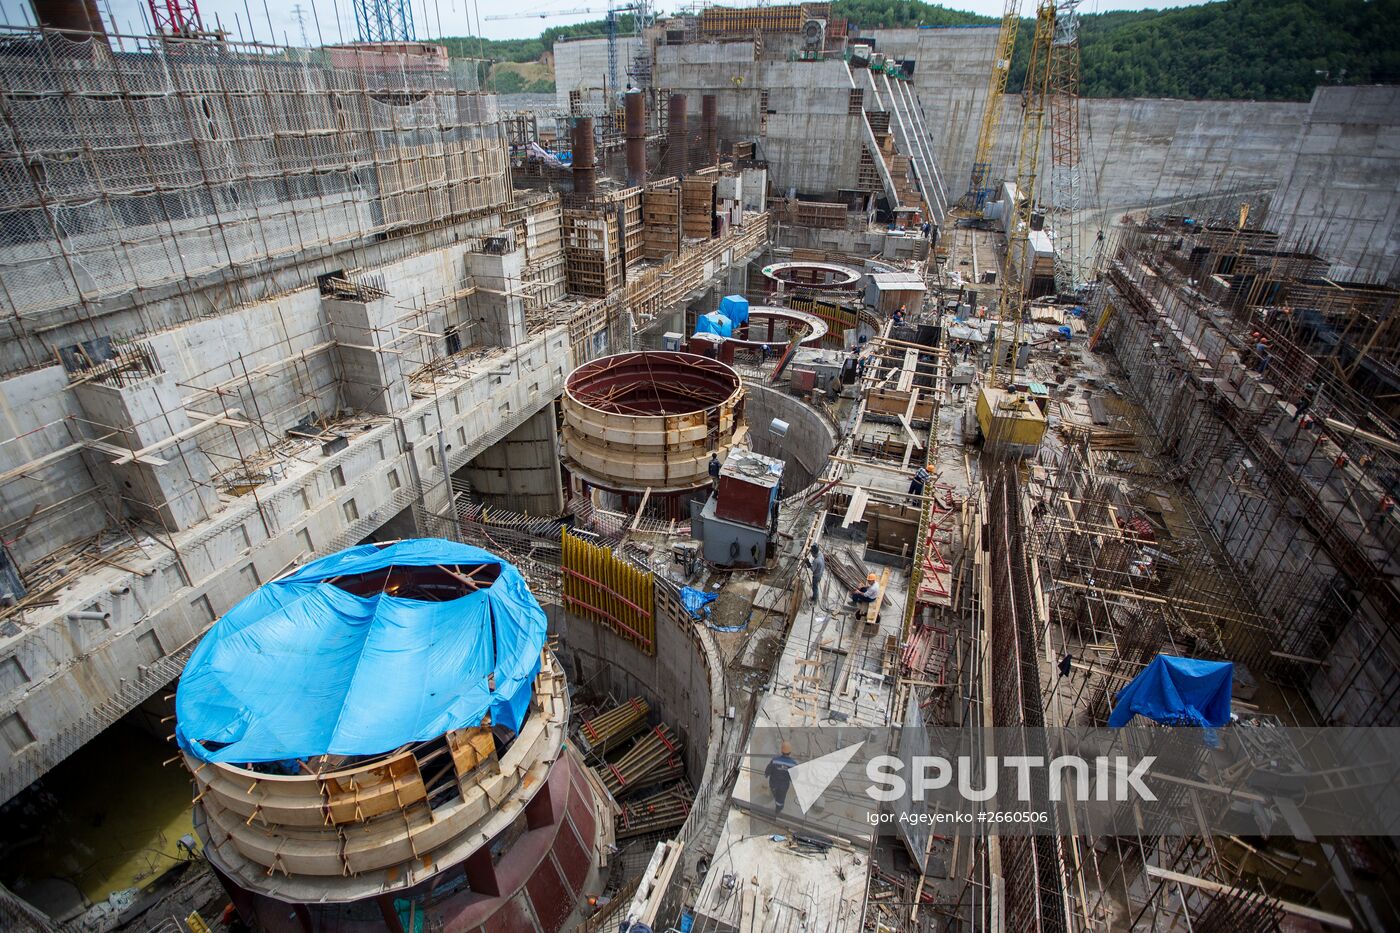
[1107,221,1400,726]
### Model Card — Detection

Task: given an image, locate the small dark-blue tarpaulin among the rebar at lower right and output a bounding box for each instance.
[1109,654,1235,728]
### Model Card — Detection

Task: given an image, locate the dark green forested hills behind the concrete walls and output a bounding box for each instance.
[442,0,1400,101]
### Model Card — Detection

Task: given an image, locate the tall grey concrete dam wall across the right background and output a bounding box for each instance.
[772,27,1400,282]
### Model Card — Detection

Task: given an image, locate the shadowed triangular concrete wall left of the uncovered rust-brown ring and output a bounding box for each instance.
[456,406,564,516]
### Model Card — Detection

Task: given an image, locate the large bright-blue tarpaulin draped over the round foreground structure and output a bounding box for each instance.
[175,538,546,762]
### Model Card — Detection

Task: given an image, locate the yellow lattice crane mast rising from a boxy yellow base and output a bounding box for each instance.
[977,0,1056,452]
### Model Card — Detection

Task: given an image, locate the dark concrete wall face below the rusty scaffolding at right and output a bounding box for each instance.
[1109,267,1400,726]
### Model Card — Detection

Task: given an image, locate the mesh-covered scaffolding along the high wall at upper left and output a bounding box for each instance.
[0,27,511,363]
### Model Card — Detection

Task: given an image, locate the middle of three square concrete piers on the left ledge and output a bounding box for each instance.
[321,297,410,415]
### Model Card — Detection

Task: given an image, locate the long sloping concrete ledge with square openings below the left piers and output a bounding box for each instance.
[0,318,570,799]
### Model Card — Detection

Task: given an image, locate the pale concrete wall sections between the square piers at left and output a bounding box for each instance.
[0,233,495,566]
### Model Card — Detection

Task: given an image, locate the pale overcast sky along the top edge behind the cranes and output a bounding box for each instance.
[0,0,1200,45]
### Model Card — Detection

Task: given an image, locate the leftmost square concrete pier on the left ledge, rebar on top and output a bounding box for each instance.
[73,373,218,531]
